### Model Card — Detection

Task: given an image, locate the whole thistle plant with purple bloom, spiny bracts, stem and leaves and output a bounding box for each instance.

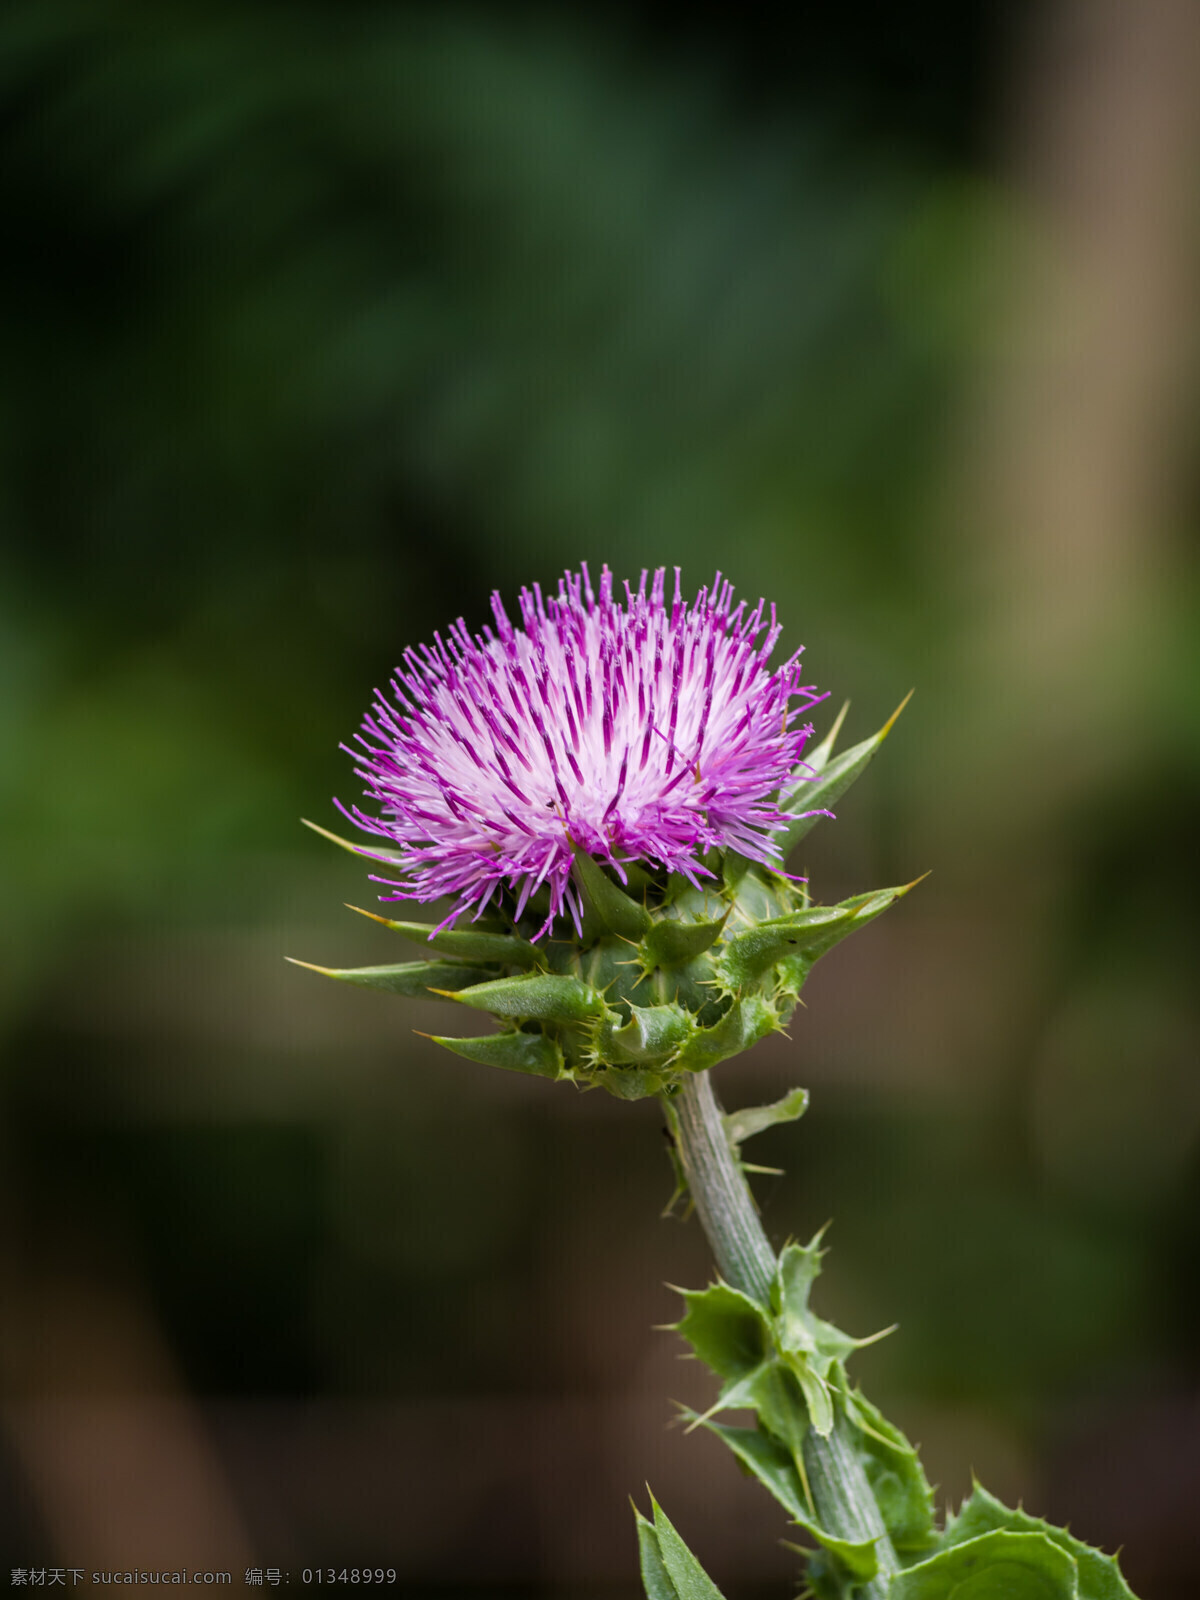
[289,592,1133,1600]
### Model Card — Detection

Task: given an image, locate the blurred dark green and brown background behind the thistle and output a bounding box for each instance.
[0,0,1200,1600]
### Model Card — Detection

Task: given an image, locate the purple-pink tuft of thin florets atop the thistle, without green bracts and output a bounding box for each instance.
[342,565,824,933]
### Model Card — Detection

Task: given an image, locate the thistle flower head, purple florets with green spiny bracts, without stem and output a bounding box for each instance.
[301,566,902,1099]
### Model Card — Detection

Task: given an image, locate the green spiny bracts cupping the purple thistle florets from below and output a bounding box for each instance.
[299,704,910,1099]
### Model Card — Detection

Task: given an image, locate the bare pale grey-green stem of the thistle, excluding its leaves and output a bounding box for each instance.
[670,1072,899,1600]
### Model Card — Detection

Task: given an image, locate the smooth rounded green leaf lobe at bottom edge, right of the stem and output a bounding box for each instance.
[888,1531,1082,1600]
